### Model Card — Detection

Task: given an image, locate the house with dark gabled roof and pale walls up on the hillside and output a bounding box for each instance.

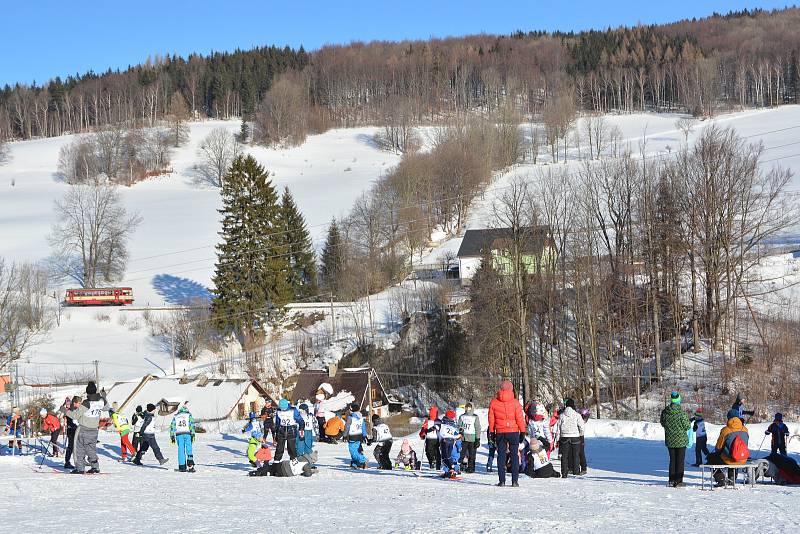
[456,225,555,284]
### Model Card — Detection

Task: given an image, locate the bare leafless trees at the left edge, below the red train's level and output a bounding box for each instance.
[0,257,56,369]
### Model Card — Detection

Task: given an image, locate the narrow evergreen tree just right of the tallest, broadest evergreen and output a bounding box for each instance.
[280,187,317,299]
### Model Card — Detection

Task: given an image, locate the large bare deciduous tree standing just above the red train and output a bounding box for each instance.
[48,185,141,287]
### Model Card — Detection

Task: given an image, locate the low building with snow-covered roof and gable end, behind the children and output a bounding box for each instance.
[107,374,273,422]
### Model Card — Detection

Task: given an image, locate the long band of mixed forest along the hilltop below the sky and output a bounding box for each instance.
[0,8,800,143]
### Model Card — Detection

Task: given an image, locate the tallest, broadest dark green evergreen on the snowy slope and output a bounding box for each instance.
[212,155,292,346]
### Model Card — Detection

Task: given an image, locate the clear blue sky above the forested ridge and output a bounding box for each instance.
[0,0,788,84]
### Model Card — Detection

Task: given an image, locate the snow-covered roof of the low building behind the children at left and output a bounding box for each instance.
[106,375,269,421]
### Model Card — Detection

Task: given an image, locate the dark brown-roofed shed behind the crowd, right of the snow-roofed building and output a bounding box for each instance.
[292,366,390,417]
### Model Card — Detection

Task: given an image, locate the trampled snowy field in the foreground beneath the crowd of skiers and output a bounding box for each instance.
[0,420,800,533]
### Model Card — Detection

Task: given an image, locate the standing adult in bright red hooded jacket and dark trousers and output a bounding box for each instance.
[489,380,525,487]
